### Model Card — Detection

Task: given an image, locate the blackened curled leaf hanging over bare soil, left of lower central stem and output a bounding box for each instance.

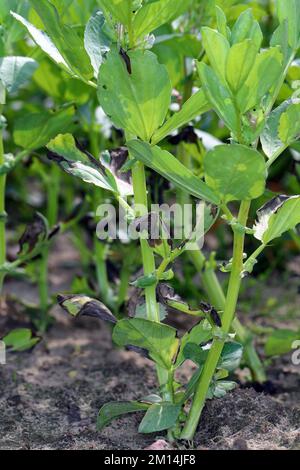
[57,294,117,324]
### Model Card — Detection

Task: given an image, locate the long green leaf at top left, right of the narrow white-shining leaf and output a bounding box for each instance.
[30,0,93,80]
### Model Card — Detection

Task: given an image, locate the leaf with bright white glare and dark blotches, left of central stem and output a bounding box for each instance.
[47,134,132,196]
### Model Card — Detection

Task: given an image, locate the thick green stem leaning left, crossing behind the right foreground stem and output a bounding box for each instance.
[190,250,267,383]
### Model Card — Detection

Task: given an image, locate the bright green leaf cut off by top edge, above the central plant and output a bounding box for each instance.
[133,0,192,40]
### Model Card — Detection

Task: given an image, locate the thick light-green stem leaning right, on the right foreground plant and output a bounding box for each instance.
[181,201,251,440]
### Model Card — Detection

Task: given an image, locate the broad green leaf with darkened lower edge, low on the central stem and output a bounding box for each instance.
[113,318,178,369]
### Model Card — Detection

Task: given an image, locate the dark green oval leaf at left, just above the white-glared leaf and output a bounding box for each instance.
[13,106,74,150]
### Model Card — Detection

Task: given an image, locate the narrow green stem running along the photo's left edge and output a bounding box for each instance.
[0,104,6,296]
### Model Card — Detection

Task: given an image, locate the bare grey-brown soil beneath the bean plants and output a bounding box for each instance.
[0,237,300,450]
